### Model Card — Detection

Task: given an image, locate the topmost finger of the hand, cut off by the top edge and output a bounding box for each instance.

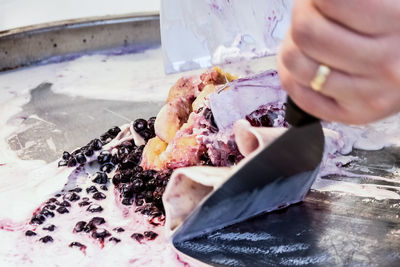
[313,0,400,35]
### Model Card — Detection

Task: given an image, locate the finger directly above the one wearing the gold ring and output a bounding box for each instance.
[290,0,381,75]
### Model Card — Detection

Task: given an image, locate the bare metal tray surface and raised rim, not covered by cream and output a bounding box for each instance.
[0,14,400,266]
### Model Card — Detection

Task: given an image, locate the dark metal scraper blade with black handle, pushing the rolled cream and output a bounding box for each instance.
[172,97,324,246]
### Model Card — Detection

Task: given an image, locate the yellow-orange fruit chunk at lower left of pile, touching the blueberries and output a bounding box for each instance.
[141,136,167,170]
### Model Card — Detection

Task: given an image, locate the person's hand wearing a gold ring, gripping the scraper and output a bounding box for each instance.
[278,0,400,124]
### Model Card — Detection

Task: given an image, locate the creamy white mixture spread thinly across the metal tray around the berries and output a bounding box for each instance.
[0,49,400,266]
